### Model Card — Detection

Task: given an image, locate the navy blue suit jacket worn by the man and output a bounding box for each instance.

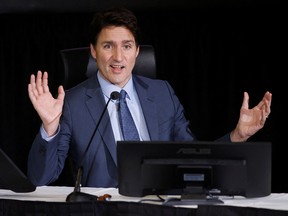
[28,75,230,187]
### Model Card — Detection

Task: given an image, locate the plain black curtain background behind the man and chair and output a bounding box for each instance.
[0,0,288,192]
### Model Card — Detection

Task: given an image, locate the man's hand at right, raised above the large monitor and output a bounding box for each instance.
[231,91,272,142]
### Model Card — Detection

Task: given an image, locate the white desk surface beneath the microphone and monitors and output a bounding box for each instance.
[0,186,288,211]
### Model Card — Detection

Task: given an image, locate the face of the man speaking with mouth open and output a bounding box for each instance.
[90,26,139,88]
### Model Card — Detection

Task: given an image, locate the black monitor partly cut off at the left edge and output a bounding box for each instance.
[0,149,36,193]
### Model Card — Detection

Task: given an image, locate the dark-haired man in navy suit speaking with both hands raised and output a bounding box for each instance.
[28,8,272,187]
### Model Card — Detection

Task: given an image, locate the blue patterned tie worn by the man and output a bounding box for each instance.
[119,89,140,140]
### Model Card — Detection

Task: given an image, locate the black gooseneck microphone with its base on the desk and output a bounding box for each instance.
[66,91,120,202]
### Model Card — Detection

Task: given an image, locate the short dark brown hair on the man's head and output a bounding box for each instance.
[89,7,139,46]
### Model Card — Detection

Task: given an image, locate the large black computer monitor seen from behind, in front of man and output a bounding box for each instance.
[117,141,271,204]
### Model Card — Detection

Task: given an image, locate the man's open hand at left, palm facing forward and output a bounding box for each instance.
[28,71,65,136]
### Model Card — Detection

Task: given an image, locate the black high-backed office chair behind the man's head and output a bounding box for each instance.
[60,45,156,89]
